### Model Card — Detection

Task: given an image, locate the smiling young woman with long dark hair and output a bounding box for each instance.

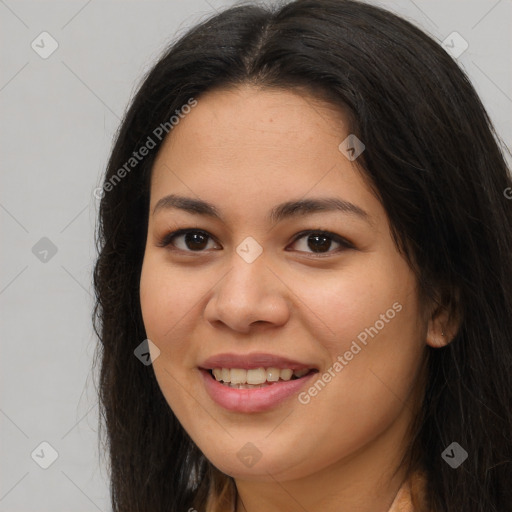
[94,0,512,512]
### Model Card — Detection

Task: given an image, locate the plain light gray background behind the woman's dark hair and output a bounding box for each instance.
[0,0,512,512]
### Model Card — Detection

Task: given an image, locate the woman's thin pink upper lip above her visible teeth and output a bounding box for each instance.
[199,352,318,370]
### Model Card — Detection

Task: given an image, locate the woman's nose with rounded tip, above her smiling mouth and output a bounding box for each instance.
[204,253,290,333]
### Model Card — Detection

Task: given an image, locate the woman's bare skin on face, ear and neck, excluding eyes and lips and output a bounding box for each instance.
[140,85,449,512]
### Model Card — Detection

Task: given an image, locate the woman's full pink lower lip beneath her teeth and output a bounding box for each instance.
[200,369,317,412]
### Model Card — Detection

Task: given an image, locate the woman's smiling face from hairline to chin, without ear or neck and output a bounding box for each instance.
[140,86,427,481]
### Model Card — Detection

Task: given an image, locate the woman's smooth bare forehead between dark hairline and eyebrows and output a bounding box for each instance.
[151,86,380,224]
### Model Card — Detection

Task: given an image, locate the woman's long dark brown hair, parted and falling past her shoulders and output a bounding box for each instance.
[93,0,512,512]
